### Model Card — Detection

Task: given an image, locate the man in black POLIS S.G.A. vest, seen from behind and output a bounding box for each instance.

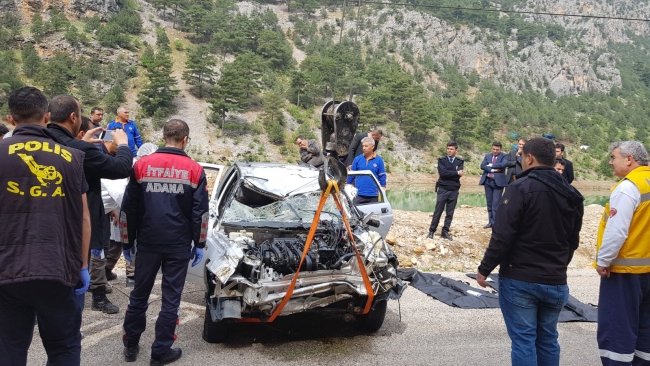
[0,87,90,365]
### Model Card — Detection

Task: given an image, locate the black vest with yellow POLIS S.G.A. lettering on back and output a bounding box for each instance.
[0,125,86,287]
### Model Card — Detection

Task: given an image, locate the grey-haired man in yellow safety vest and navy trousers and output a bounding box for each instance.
[594,141,650,365]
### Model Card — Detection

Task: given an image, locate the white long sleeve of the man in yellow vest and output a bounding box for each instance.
[596,179,641,267]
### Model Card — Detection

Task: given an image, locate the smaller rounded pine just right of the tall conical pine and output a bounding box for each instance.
[183,45,217,98]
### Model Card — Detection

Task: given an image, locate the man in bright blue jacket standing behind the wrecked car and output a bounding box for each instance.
[348,137,386,205]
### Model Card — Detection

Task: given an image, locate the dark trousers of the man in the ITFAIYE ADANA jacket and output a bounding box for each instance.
[124,246,191,358]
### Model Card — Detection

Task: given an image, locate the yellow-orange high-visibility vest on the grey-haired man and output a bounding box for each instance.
[593,166,650,274]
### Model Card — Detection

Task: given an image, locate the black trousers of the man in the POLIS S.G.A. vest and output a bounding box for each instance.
[0,281,81,366]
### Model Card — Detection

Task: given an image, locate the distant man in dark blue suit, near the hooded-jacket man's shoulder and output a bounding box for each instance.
[478,141,508,229]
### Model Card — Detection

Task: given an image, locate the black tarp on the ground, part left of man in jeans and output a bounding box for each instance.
[397,268,499,309]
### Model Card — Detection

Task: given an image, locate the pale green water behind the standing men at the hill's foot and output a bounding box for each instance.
[386,186,609,212]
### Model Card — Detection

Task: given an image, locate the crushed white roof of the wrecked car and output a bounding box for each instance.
[240,164,320,199]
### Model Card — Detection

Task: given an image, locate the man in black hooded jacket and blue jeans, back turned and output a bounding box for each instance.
[476,138,583,365]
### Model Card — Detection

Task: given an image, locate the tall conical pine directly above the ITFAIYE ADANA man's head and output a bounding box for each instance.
[137,52,178,116]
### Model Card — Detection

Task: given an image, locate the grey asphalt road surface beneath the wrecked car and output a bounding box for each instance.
[28,270,600,366]
